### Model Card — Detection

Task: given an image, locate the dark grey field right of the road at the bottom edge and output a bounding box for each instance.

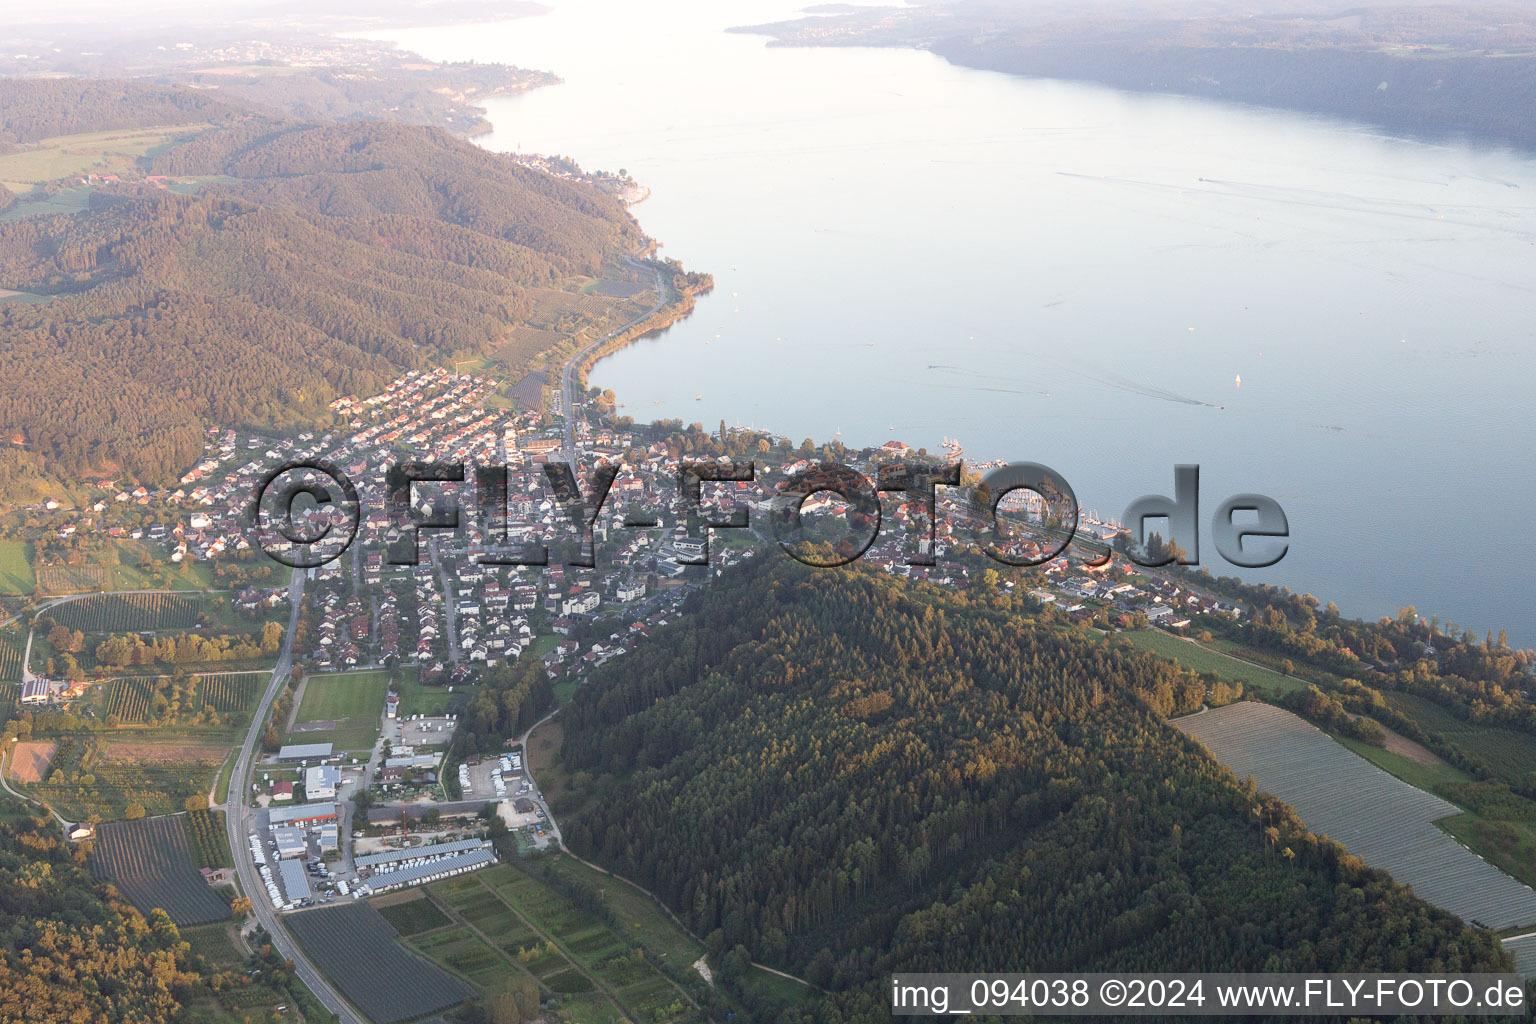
[287,903,473,1024]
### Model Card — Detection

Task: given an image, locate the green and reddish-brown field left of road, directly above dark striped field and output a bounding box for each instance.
[37,734,229,821]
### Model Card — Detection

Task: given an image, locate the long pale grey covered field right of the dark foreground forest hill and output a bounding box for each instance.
[1174,702,1536,929]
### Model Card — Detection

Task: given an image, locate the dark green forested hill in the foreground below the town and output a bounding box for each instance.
[562,559,1501,1021]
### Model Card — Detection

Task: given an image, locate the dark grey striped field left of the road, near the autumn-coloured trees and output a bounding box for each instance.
[91,817,229,926]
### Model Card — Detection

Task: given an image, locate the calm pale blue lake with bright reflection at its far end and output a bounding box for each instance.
[371,0,1536,645]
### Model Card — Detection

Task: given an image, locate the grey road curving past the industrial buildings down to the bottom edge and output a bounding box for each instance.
[224,570,370,1024]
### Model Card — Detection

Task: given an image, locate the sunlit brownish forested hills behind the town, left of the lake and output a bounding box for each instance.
[0,83,642,493]
